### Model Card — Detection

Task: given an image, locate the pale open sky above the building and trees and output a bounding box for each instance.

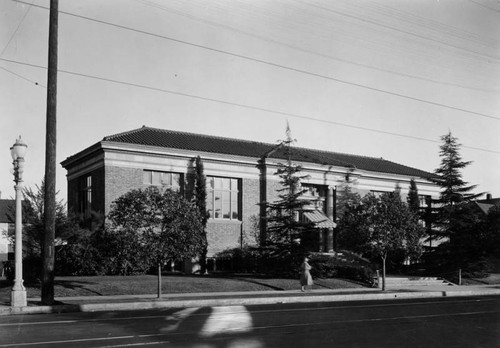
[0,0,500,201]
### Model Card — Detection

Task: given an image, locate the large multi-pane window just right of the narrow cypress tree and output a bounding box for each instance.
[207,176,240,220]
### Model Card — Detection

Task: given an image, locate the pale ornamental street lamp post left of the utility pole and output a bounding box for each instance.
[10,136,28,307]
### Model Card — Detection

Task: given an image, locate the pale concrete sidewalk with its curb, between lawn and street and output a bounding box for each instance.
[0,285,500,315]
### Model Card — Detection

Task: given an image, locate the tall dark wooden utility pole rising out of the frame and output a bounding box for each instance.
[42,0,59,305]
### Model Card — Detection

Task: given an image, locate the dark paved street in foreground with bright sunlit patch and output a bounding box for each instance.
[0,296,500,348]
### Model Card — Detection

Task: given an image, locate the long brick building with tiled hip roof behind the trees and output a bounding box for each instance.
[61,126,439,257]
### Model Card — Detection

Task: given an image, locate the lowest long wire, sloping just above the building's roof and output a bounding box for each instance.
[0,58,500,154]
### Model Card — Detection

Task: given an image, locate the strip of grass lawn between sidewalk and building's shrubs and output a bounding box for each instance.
[0,274,363,302]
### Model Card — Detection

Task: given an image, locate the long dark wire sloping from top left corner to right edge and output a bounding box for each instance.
[11,0,500,121]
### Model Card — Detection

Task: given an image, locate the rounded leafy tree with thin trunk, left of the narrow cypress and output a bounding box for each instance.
[108,186,206,297]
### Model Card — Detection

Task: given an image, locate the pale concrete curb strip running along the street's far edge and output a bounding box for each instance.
[0,289,500,316]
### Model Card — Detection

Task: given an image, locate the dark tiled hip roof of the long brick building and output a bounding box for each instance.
[95,126,434,178]
